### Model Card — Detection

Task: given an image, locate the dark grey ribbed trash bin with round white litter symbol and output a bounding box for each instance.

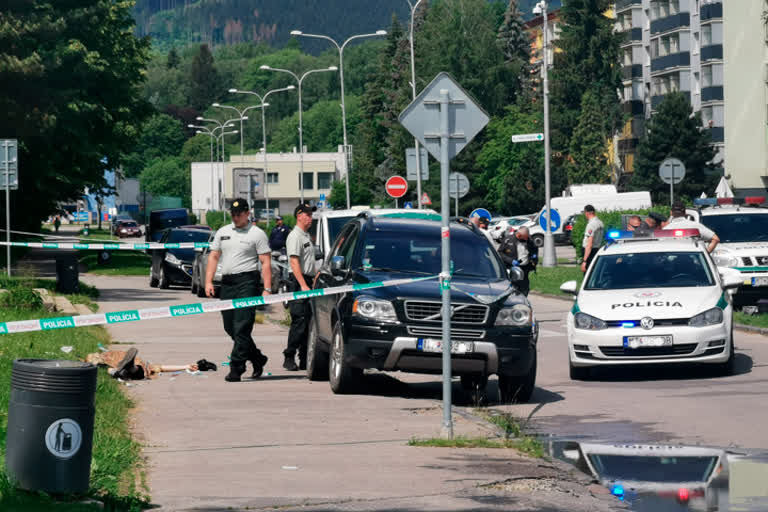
[5,359,97,493]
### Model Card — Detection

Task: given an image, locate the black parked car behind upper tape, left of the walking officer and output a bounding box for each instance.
[149,228,210,288]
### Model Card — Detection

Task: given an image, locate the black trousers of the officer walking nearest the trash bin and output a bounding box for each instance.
[221,270,264,364]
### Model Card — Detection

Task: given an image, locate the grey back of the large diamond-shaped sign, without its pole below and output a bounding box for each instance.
[400,72,490,161]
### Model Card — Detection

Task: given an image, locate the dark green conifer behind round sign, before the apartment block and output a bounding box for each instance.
[630,92,721,203]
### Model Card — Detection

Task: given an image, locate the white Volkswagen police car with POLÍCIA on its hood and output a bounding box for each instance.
[560,229,741,379]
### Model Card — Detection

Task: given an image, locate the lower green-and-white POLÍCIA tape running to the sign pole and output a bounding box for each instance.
[0,276,439,334]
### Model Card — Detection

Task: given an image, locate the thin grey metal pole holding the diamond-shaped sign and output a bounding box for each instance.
[440,89,453,438]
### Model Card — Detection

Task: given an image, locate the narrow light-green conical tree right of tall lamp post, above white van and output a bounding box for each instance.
[566,89,612,183]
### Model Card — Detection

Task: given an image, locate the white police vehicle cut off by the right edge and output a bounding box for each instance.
[687,197,768,306]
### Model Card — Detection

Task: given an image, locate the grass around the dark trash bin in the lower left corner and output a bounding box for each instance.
[0,284,148,512]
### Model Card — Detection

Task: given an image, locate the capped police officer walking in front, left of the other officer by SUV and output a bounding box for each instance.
[205,199,272,382]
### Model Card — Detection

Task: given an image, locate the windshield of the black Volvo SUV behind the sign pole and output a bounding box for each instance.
[362,230,506,280]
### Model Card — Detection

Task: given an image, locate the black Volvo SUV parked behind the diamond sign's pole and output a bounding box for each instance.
[307,211,538,402]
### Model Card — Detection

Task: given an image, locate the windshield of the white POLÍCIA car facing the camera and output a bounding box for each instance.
[585,252,715,290]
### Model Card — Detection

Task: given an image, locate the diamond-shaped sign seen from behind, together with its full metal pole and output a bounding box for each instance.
[399,73,489,438]
